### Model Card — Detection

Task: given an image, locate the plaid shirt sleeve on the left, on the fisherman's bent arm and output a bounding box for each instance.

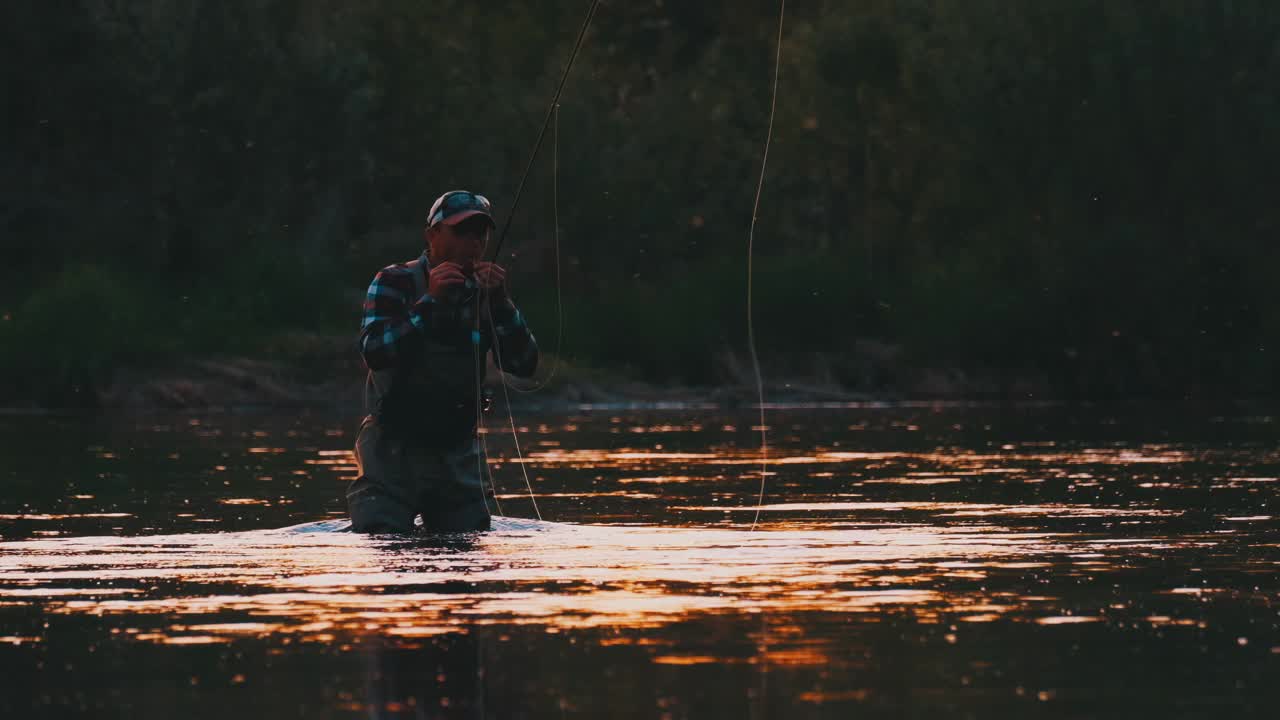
[360,269,434,370]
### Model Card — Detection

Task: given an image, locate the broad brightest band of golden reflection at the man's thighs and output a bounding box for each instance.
[0,509,1218,650]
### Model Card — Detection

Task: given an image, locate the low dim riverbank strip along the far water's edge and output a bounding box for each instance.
[0,333,1090,413]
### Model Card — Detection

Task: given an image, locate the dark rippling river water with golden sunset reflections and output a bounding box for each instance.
[0,405,1280,719]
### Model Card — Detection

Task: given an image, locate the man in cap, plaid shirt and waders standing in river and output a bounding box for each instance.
[347,190,538,533]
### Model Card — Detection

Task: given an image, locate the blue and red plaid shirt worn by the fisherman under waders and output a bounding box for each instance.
[360,252,538,378]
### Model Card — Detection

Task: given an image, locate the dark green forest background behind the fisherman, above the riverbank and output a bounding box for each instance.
[0,0,1280,402]
